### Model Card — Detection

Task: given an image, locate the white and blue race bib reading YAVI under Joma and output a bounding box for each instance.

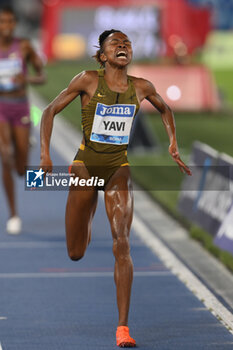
[90,103,136,145]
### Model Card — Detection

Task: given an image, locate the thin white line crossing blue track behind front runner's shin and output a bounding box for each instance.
[0,271,171,279]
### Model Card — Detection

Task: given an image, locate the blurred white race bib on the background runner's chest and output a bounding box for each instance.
[0,58,22,91]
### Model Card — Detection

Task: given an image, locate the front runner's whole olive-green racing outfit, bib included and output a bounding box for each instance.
[74,69,139,186]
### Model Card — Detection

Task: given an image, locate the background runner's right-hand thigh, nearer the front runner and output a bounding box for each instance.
[12,126,30,175]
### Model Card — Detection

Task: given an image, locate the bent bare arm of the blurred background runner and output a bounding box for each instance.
[21,39,46,85]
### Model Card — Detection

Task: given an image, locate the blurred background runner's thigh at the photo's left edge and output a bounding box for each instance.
[0,121,13,162]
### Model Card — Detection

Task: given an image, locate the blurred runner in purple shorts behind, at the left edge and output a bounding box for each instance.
[0,6,45,234]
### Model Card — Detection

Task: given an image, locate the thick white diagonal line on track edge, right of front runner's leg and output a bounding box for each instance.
[132,215,233,333]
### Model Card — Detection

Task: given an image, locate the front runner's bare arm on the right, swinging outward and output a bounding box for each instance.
[140,79,192,175]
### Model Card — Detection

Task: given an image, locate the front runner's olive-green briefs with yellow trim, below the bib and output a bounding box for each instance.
[74,144,129,190]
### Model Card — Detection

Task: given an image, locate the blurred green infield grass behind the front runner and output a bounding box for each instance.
[33,61,233,271]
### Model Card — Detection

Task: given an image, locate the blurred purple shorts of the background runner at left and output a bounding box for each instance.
[0,97,30,127]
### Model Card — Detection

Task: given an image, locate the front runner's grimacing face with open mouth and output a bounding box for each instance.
[100,33,133,67]
